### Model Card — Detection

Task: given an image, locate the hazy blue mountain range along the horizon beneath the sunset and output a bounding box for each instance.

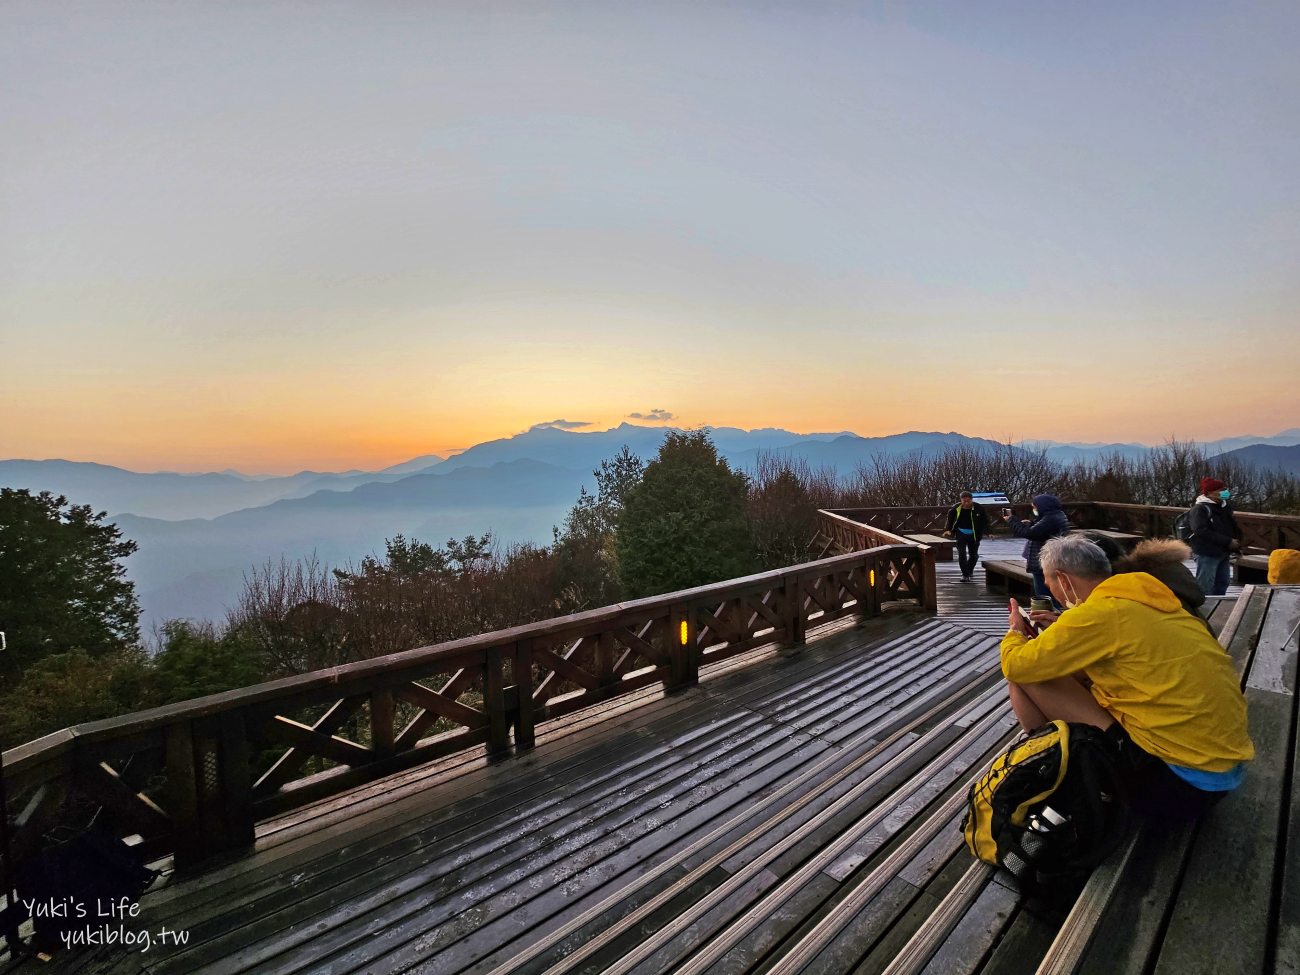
[0,424,1300,627]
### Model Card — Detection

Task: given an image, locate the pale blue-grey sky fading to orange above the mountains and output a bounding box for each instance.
[0,0,1300,472]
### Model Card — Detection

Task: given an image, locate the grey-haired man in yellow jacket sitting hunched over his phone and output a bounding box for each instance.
[1002,536,1255,818]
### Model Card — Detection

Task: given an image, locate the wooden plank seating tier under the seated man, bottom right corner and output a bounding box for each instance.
[1037,586,1300,975]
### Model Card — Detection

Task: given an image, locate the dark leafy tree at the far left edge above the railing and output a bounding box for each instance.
[0,488,140,671]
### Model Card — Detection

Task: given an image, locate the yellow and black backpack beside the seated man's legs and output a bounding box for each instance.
[962,722,1128,889]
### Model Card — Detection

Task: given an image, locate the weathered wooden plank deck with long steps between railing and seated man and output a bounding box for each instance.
[7,553,1268,975]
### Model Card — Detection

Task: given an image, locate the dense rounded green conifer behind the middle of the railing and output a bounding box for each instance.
[615,430,757,597]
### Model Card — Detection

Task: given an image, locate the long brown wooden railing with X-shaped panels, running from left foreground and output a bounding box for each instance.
[4,546,935,868]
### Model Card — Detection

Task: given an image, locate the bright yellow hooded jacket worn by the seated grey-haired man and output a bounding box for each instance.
[1002,572,1255,772]
